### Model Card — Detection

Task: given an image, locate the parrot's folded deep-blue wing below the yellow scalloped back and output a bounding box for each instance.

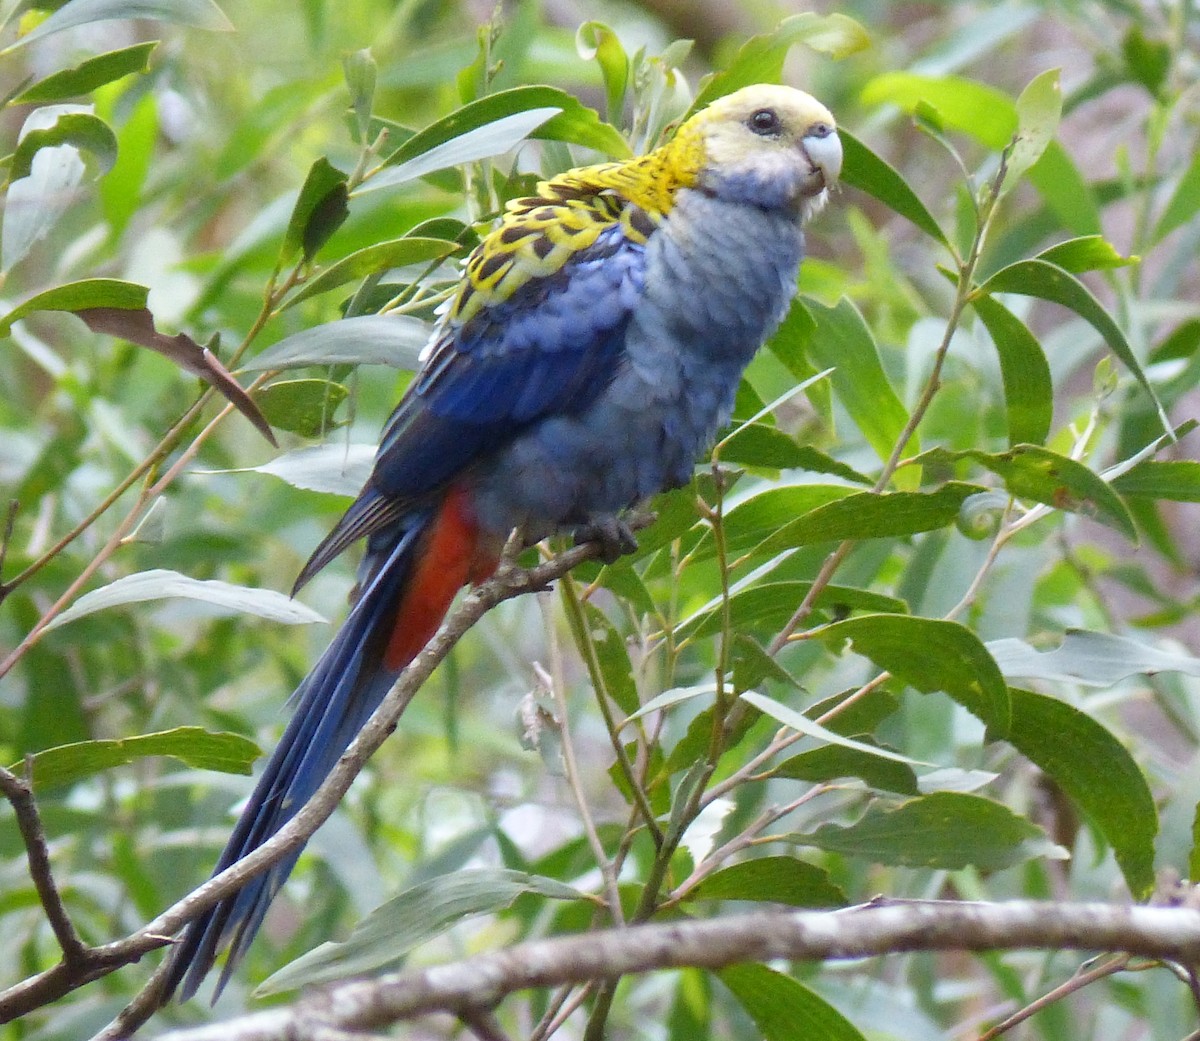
[295,222,646,589]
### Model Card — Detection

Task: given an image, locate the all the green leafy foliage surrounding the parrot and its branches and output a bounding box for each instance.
[0,0,1200,1041]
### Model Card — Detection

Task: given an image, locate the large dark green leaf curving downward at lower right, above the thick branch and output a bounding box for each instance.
[1008,686,1156,901]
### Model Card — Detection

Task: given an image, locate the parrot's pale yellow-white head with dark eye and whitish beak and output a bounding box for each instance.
[668,84,841,216]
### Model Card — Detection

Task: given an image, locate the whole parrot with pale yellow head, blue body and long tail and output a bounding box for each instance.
[162,84,842,1001]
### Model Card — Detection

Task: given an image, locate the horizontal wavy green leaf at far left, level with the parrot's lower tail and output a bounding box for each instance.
[19,727,263,788]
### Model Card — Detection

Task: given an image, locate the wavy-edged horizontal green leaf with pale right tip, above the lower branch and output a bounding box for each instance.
[788,792,1064,871]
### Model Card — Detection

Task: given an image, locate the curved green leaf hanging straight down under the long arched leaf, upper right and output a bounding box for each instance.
[972,290,1051,445]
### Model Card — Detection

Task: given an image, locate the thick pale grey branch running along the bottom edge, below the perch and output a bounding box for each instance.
[152,901,1200,1041]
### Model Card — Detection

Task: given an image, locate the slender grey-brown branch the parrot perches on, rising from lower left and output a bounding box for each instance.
[0,532,628,1023]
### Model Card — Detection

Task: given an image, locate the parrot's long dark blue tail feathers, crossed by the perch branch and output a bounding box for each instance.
[162,525,432,1001]
